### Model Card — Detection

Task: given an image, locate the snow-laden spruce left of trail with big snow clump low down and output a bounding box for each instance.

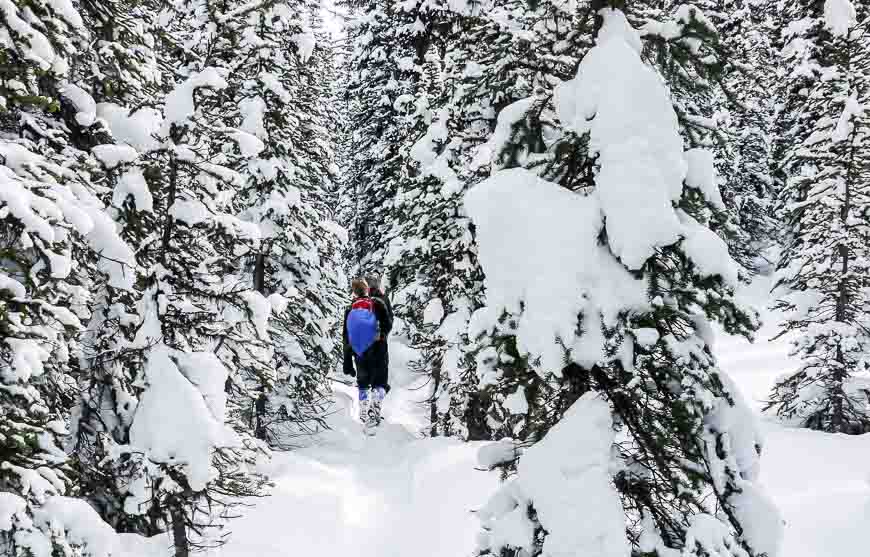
[67,3,280,556]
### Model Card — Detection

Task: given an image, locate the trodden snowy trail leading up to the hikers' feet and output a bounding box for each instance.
[215,332,498,557]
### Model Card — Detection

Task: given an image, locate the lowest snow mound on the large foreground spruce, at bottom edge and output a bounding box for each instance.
[479,393,630,557]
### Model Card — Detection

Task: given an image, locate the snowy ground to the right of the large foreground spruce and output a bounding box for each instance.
[715,279,870,557]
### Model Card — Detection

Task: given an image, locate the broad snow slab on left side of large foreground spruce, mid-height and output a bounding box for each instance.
[465,169,647,371]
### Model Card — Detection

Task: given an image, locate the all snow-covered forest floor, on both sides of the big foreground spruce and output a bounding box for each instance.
[217,280,870,557]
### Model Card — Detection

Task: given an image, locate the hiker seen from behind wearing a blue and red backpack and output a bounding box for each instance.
[342,279,393,427]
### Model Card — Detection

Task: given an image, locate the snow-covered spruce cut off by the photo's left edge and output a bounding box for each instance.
[0,137,133,557]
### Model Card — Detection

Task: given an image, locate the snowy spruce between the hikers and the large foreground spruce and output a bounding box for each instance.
[396,1,591,439]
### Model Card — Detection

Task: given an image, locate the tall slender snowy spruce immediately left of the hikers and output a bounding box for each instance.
[227,1,344,448]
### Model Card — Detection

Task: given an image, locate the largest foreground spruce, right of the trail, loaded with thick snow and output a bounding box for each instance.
[466,2,781,556]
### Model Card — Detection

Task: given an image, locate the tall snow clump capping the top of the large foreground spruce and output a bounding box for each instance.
[556,11,686,269]
